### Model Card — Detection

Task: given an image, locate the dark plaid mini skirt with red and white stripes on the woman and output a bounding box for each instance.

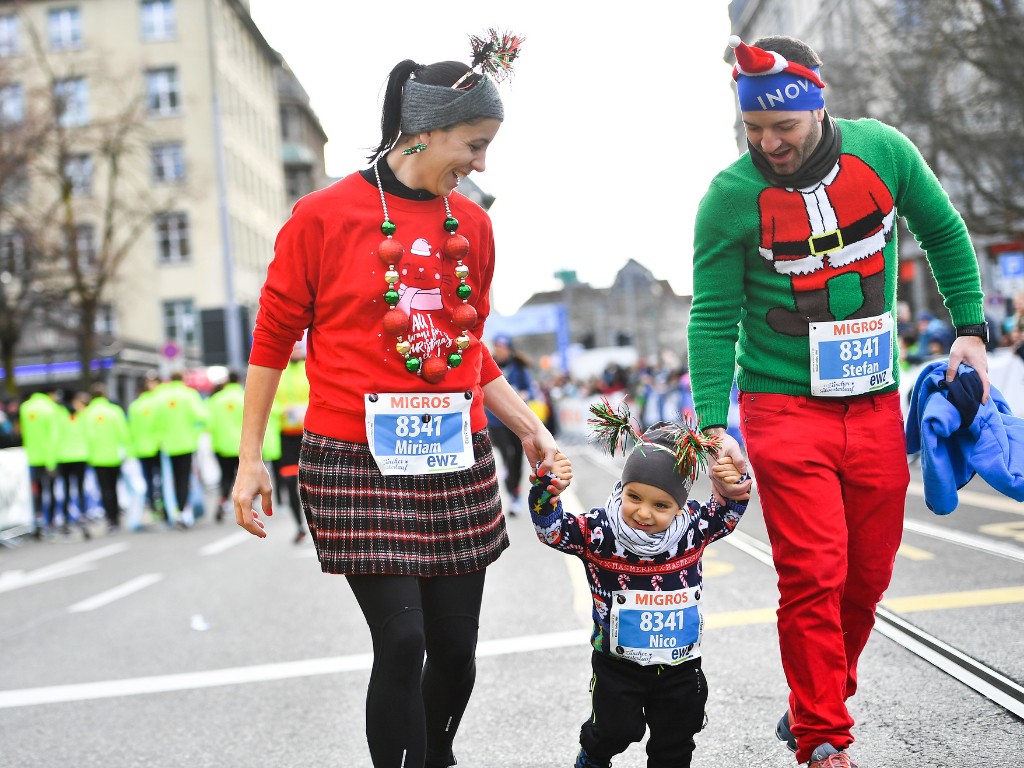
[299,430,509,577]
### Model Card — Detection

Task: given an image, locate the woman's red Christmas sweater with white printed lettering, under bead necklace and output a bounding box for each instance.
[249,173,501,442]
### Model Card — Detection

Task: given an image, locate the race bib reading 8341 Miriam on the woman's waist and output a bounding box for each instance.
[364,392,474,475]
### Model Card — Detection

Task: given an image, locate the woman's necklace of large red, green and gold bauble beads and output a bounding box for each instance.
[374,158,476,384]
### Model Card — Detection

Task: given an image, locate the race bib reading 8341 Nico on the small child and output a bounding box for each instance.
[608,587,703,666]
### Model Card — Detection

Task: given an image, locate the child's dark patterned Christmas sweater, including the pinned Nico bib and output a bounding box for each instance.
[529,484,746,666]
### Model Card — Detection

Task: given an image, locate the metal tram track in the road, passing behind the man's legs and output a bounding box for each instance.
[722,530,1024,720]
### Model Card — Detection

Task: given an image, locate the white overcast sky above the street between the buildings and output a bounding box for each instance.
[251,0,737,314]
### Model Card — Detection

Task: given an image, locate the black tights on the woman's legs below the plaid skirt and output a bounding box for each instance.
[347,570,485,768]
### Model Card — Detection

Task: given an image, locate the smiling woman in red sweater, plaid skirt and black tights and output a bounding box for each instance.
[232,36,556,768]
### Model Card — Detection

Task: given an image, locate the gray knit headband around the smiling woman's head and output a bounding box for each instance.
[401,76,505,133]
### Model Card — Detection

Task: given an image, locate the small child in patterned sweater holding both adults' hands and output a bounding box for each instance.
[529,411,748,768]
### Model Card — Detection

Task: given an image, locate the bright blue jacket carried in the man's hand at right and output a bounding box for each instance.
[906,360,1024,515]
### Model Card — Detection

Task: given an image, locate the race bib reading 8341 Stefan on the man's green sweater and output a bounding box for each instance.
[810,313,895,397]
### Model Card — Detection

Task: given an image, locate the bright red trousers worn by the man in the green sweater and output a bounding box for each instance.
[739,392,910,763]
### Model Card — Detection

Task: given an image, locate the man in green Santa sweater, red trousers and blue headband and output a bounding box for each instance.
[689,37,988,768]
